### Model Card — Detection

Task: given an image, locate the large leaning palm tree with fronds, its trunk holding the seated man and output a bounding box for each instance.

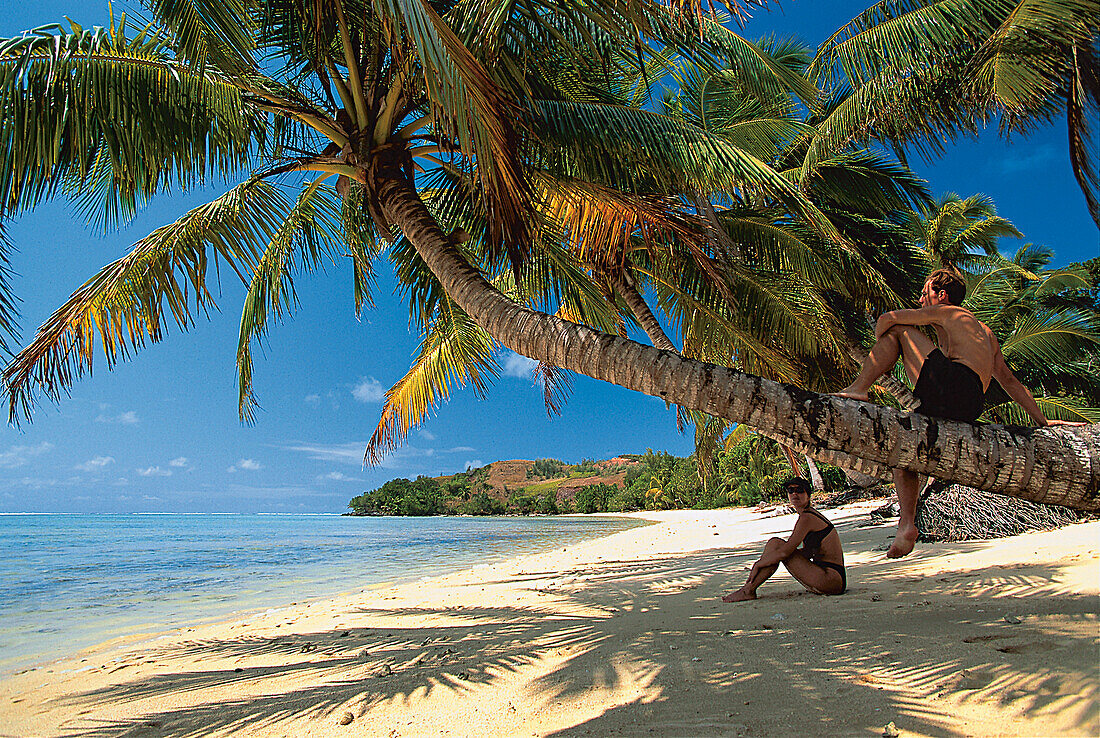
[0,0,1100,508]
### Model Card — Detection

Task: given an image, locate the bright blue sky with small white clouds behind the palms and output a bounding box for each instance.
[0,0,1100,513]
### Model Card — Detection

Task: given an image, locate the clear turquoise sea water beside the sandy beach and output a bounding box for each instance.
[0,514,644,673]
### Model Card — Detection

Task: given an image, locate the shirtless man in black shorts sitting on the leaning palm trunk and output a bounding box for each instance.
[834,269,1059,559]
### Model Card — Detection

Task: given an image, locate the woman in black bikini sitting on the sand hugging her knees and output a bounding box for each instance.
[722,476,848,603]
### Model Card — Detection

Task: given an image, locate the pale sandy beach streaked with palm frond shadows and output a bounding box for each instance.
[0,504,1100,738]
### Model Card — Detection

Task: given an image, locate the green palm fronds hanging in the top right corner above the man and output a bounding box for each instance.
[810,0,1100,227]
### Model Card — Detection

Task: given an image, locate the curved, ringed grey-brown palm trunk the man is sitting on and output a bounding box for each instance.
[372,170,1100,510]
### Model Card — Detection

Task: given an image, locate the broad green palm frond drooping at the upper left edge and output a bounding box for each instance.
[0,22,265,219]
